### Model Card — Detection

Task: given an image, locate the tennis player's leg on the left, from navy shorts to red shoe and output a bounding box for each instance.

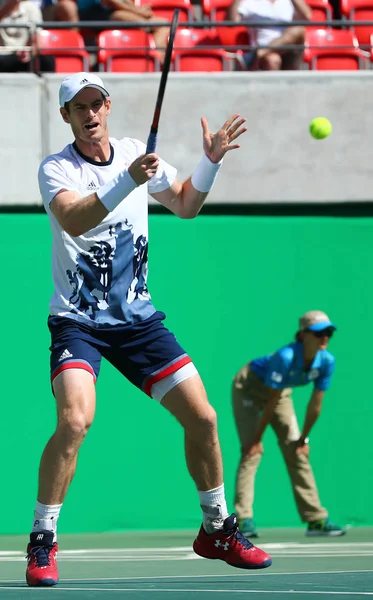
[26,317,101,586]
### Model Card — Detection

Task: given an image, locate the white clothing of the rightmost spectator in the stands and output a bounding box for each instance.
[238,0,294,46]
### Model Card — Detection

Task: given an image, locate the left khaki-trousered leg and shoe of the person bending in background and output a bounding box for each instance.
[232,365,262,538]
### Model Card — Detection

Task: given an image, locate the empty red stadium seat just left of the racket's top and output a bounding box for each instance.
[97,29,160,73]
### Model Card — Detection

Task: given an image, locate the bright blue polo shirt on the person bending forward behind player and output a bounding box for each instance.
[250,342,335,391]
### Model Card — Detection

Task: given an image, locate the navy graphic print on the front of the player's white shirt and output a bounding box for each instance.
[66,220,150,320]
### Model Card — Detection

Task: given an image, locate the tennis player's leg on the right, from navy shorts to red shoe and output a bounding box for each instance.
[103,313,271,569]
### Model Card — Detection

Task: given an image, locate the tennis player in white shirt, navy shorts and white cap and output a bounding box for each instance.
[26,73,271,586]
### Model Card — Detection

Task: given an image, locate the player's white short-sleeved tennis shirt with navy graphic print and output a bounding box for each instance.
[39,138,176,327]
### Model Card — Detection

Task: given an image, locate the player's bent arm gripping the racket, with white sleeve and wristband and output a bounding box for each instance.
[39,154,159,237]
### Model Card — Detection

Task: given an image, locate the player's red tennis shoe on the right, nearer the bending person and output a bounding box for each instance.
[193,514,272,569]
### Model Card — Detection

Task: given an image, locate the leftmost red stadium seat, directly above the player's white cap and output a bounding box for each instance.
[38,29,89,73]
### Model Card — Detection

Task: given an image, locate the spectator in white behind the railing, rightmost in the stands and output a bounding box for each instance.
[228,0,312,71]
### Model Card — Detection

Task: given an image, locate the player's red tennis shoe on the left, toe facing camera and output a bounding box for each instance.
[26,531,58,586]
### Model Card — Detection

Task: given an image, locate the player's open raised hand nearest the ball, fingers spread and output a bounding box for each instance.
[201,114,247,163]
